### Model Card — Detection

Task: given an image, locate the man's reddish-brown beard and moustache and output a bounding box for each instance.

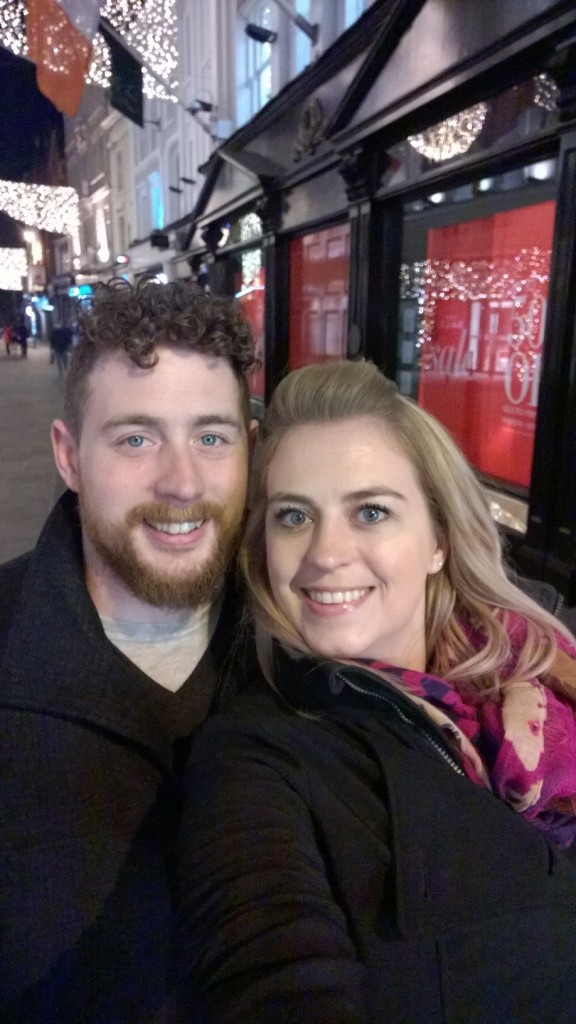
[78,492,243,609]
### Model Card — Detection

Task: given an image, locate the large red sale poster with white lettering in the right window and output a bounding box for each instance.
[418,202,556,486]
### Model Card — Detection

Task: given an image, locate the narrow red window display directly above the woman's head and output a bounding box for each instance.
[290,223,349,370]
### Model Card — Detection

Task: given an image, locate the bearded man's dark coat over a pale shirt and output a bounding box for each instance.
[0,494,243,1024]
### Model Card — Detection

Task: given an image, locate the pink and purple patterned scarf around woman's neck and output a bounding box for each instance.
[367,613,576,847]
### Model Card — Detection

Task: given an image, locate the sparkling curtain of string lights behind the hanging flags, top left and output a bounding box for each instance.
[0,0,178,98]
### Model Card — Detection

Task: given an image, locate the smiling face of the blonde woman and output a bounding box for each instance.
[265,417,444,671]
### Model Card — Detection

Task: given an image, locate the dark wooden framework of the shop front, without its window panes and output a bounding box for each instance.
[181,0,576,604]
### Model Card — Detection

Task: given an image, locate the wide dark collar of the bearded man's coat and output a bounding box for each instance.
[0,492,238,766]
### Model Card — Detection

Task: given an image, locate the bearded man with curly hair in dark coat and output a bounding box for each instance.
[0,283,254,1024]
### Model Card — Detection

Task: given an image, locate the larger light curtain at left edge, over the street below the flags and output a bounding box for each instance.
[0,180,80,237]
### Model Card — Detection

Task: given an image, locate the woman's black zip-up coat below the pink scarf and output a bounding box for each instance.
[180,658,576,1024]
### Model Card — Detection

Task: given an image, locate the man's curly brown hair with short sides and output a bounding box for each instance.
[65,279,258,436]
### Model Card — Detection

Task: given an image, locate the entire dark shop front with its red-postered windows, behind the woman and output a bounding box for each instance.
[181,0,576,604]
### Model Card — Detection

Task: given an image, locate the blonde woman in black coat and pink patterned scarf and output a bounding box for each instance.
[177,362,576,1024]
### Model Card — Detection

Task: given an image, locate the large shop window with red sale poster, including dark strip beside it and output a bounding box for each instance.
[398,174,556,495]
